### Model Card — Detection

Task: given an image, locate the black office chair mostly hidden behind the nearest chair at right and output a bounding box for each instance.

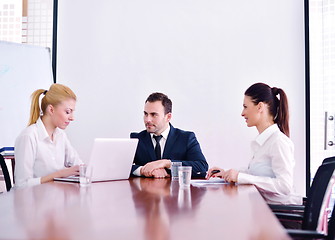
[269,157,335,215]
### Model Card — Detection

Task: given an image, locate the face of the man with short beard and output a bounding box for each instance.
[143,101,171,135]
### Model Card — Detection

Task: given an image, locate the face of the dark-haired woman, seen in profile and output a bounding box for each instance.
[241,96,261,127]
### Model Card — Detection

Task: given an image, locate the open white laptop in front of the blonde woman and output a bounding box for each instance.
[54,138,138,182]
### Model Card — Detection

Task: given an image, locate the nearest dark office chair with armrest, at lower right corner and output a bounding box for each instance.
[275,162,335,231]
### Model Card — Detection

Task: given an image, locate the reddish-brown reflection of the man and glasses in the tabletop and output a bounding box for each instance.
[129,178,206,240]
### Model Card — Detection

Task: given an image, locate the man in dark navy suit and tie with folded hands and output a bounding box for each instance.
[130,93,208,178]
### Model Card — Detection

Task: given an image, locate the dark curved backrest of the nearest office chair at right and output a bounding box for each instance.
[302,157,335,230]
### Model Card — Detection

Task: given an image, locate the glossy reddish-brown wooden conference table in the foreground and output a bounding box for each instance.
[0,178,289,240]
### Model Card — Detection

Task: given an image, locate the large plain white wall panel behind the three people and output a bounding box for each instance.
[57,0,305,194]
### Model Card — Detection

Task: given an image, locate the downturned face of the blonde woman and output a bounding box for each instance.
[50,99,76,129]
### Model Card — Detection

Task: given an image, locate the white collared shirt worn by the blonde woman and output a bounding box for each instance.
[14,118,82,187]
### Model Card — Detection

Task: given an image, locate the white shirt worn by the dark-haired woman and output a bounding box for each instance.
[237,124,302,204]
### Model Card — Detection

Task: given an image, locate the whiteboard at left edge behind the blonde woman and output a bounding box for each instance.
[0,41,53,147]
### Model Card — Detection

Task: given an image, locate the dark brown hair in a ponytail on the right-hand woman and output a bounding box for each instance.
[244,83,290,137]
